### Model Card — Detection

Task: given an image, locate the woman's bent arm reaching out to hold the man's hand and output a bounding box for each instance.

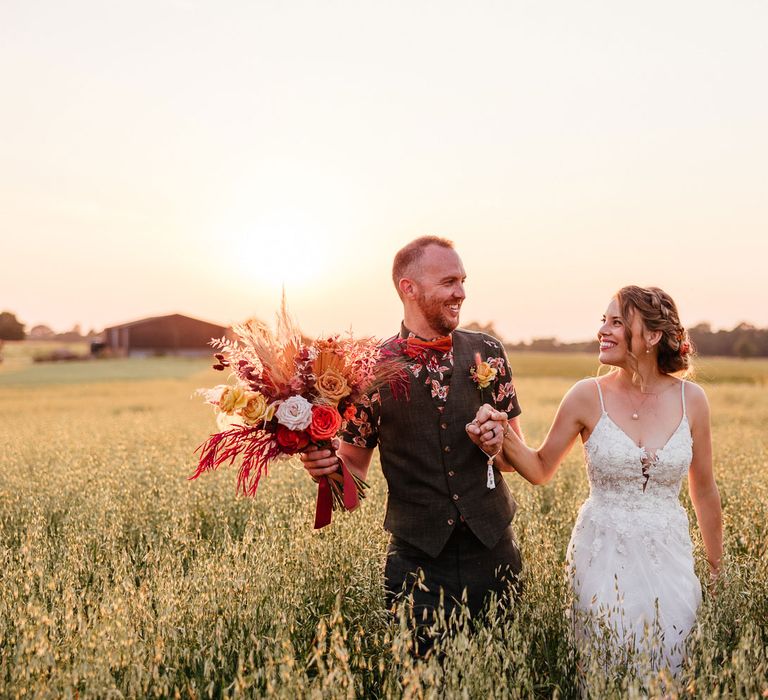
[480,381,594,484]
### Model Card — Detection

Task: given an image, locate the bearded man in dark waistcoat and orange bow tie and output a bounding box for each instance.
[302,236,521,653]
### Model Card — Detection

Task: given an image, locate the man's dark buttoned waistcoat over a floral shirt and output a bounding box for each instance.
[378,330,516,557]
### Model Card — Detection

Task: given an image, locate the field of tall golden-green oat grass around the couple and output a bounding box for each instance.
[0,346,768,698]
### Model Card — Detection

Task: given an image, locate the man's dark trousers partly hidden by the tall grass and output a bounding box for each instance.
[384,523,522,656]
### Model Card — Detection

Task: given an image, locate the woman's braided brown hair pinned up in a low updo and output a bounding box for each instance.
[616,285,693,374]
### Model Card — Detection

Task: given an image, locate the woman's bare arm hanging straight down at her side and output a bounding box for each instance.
[685,383,723,575]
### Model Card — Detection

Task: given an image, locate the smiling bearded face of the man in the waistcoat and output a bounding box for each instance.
[401,245,466,337]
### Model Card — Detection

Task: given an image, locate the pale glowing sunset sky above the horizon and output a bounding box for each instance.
[0,0,768,341]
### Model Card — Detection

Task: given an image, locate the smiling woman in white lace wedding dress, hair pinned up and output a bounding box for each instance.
[467,286,722,673]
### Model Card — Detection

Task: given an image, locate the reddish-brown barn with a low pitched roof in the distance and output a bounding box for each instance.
[103,314,229,357]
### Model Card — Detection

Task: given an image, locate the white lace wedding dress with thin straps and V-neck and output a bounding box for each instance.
[567,380,701,673]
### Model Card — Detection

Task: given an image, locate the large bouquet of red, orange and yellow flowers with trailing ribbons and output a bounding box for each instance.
[190,302,402,528]
